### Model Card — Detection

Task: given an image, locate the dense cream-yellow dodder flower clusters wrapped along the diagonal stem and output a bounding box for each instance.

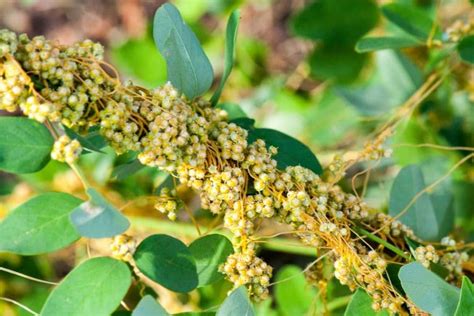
[0,31,470,314]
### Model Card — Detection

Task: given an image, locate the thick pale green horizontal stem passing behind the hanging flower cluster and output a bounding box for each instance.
[128,216,317,257]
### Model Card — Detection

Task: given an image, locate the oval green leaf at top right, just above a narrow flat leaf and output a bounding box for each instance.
[382,3,441,41]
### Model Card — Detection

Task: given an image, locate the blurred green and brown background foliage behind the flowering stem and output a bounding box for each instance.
[0,0,474,316]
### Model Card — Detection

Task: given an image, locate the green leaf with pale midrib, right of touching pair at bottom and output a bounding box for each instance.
[189,234,234,287]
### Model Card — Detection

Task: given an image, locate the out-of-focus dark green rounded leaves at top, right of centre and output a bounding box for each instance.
[291,0,378,82]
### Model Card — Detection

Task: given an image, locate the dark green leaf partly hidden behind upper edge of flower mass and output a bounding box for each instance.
[248,128,323,174]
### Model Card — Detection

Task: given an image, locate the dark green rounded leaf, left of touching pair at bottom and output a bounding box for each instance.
[133,234,198,292]
